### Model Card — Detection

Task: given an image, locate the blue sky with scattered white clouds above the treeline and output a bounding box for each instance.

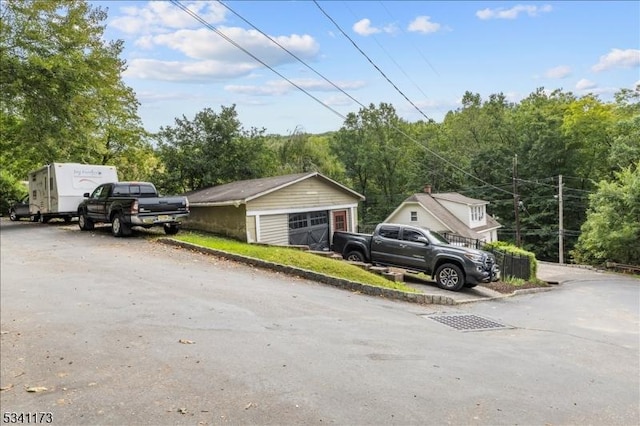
[95,0,640,135]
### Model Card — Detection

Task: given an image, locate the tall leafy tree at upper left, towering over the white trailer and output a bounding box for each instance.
[0,0,153,184]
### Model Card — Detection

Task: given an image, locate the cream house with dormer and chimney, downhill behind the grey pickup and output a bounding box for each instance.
[385,185,502,243]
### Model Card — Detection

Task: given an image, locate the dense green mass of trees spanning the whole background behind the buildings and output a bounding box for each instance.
[0,0,640,264]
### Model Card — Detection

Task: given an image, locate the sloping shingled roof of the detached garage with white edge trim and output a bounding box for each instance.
[184,172,364,206]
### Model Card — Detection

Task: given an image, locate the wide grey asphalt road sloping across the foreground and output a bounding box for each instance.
[0,219,640,425]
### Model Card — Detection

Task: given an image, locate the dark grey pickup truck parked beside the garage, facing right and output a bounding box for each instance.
[332,223,500,291]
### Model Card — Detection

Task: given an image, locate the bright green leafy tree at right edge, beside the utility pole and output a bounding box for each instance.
[572,163,640,265]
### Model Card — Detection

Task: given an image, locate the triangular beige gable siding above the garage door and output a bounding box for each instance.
[248,177,354,211]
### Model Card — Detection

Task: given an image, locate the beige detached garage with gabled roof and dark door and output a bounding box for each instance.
[185,172,364,250]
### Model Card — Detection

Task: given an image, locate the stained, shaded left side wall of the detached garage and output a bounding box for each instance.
[184,205,247,241]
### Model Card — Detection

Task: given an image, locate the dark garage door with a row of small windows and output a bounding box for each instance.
[289,211,329,250]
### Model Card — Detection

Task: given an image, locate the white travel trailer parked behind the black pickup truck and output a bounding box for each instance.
[29,163,118,222]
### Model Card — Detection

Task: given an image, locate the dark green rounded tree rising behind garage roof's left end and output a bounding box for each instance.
[156,105,275,192]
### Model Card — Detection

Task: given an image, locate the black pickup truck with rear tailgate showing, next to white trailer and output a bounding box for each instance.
[78,182,189,237]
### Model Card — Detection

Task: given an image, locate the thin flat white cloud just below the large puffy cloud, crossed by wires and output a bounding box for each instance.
[225,78,364,96]
